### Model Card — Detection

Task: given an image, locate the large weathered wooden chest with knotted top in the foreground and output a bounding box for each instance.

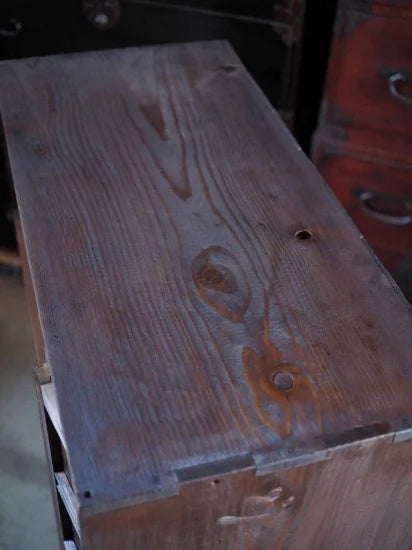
[0,42,412,550]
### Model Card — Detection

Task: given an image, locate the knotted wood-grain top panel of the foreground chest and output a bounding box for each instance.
[0,43,412,506]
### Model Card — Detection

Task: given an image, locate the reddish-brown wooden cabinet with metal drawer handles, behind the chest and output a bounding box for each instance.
[313,0,412,299]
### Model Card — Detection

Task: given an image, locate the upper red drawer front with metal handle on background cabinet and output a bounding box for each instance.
[327,12,412,135]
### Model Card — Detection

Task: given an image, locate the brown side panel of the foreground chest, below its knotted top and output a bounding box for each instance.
[82,439,412,550]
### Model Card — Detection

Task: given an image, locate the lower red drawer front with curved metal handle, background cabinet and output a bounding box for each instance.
[317,153,412,256]
